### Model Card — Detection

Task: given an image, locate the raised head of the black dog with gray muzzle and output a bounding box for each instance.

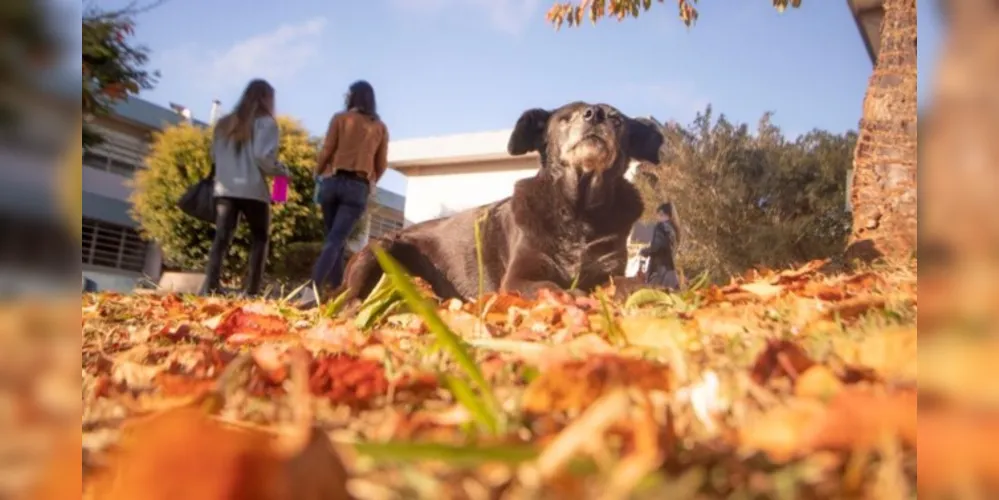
[507,102,664,174]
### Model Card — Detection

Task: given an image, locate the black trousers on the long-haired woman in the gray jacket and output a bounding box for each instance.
[202,197,271,295]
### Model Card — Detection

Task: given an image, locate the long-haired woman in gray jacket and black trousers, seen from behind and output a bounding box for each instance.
[202,79,289,296]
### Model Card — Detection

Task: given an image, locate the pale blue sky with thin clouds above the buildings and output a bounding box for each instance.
[80,0,939,192]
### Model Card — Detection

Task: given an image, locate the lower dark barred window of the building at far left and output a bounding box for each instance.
[83,217,148,273]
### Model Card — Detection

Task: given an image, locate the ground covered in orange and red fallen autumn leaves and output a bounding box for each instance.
[82,260,917,499]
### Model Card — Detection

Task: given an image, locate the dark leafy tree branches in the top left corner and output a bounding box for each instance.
[82,3,158,148]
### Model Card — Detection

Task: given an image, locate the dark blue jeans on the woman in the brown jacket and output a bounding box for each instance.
[312,176,371,289]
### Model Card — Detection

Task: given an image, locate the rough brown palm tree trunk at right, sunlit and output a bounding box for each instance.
[847,0,917,260]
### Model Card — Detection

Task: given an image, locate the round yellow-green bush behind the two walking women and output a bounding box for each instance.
[131,117,323,282]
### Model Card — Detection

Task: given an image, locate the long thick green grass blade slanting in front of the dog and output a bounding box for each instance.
[371,245,499,408]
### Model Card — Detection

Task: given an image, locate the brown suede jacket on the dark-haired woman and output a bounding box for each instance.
[316,110,388,186]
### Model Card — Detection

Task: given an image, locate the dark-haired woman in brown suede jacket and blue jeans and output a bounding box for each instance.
[312,80,389,290]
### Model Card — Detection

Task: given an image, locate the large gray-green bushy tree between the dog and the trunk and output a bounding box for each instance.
[635,106,856,280]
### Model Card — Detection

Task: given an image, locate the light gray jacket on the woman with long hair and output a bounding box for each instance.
[212,116,289,203]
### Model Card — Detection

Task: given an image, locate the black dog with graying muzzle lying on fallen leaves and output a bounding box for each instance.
[346,102,663,299]
